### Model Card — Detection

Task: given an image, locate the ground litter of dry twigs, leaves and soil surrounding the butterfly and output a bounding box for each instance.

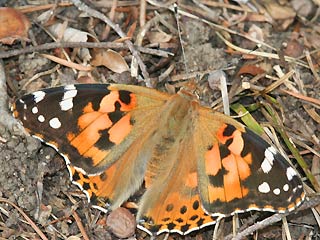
[0,0,320,239]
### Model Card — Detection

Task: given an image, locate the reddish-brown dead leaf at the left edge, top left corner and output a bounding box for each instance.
[0,7,31,45]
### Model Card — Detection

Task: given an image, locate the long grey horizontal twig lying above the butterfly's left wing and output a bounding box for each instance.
[0,42,172,59]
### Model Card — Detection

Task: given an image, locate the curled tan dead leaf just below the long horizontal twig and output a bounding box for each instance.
[91,49,129,73]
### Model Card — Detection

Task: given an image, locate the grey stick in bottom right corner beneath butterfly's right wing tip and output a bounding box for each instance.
[224,195,320,240]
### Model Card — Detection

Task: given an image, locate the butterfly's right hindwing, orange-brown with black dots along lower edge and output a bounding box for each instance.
[137,130,215,235]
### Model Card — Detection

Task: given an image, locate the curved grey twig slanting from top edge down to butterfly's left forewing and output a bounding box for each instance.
[72,0,152,87]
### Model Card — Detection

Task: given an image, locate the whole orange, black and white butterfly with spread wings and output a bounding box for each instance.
[13,84,305,235]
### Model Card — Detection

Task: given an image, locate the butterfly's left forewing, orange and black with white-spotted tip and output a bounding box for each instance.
[14,84,170,174]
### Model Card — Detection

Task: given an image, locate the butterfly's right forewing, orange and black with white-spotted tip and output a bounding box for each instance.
[194,108,305,215]
